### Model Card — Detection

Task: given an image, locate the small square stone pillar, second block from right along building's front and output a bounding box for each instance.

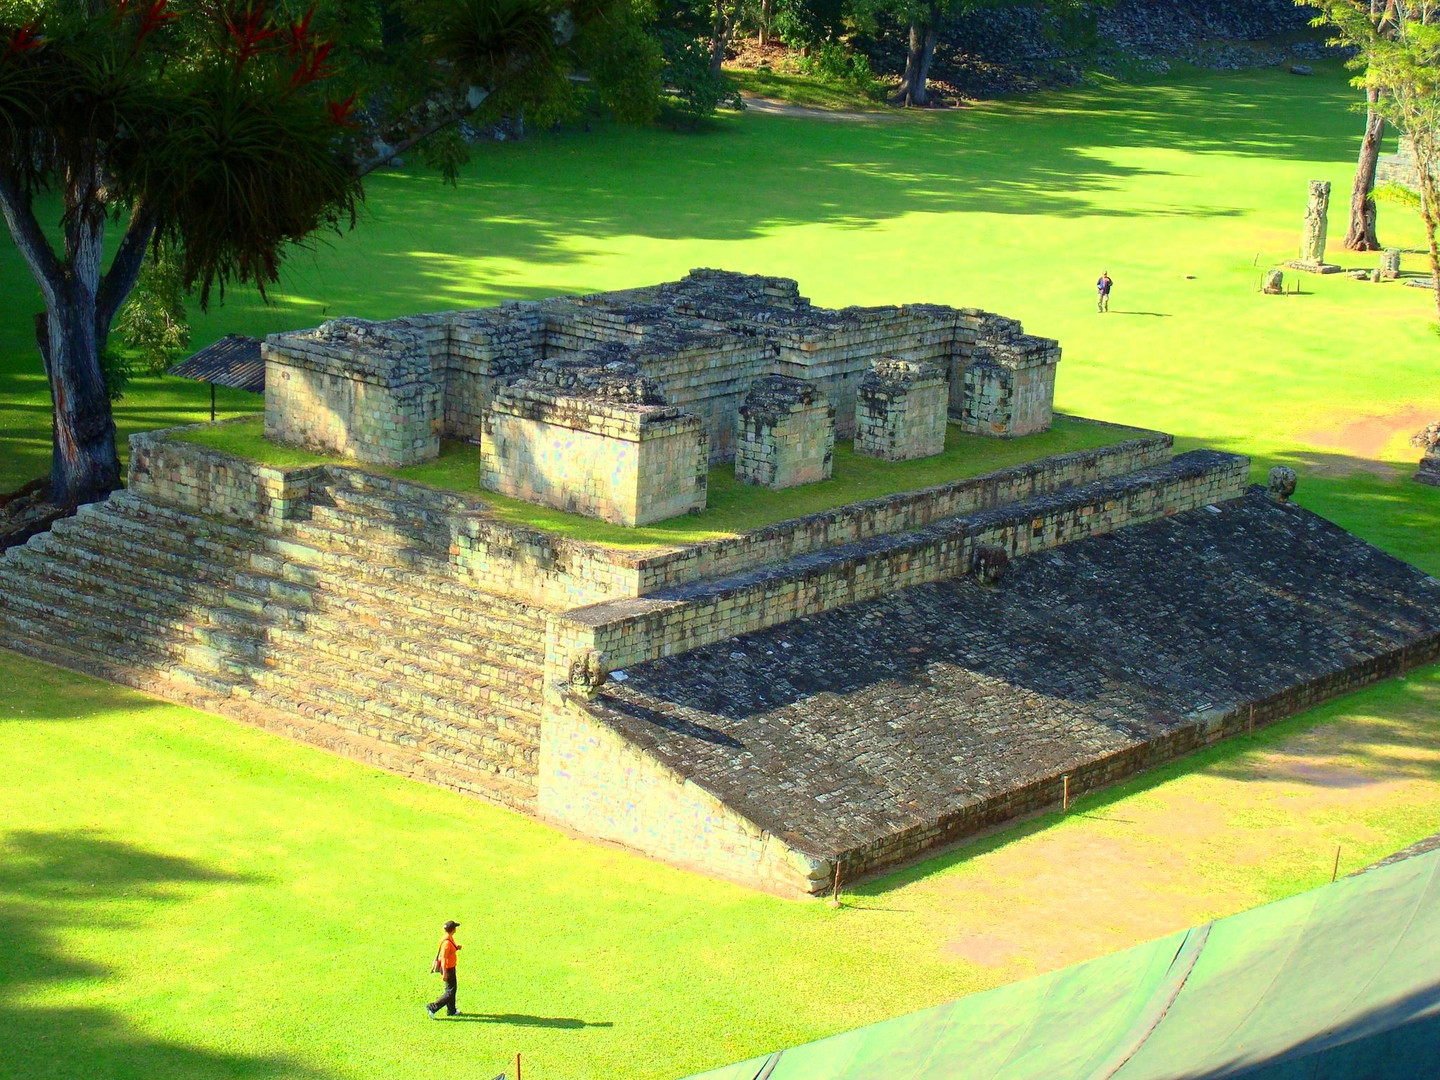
[855,359,950,461]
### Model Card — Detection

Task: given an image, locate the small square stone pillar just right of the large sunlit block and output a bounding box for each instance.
[734,374,840,490]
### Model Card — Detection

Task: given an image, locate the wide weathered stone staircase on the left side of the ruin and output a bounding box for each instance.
[0,474,547,811]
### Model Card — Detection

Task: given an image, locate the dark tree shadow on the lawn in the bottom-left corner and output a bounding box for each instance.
[0,829,324,1080]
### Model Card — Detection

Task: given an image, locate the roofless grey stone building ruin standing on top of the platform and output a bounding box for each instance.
[264,271,1060,526]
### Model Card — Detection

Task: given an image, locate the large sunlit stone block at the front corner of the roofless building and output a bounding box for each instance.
[480,360,710,526]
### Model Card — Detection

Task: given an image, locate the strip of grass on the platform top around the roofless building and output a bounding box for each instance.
[179,416,1138,547]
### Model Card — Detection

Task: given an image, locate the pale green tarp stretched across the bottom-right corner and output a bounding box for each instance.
[693,851,1440,1080]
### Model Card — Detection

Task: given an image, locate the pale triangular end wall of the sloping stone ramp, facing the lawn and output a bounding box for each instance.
[539,696,829,896]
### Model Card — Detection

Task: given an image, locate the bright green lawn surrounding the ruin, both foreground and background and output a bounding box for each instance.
[0,59,1440,1080]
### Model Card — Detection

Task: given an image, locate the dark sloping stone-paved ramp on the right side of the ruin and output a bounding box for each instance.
[576,488,1440,887]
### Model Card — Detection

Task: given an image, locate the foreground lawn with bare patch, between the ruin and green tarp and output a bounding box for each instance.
[0,652,1440,1080]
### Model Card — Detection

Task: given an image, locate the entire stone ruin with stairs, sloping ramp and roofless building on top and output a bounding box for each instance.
[0,271,1440,896]
